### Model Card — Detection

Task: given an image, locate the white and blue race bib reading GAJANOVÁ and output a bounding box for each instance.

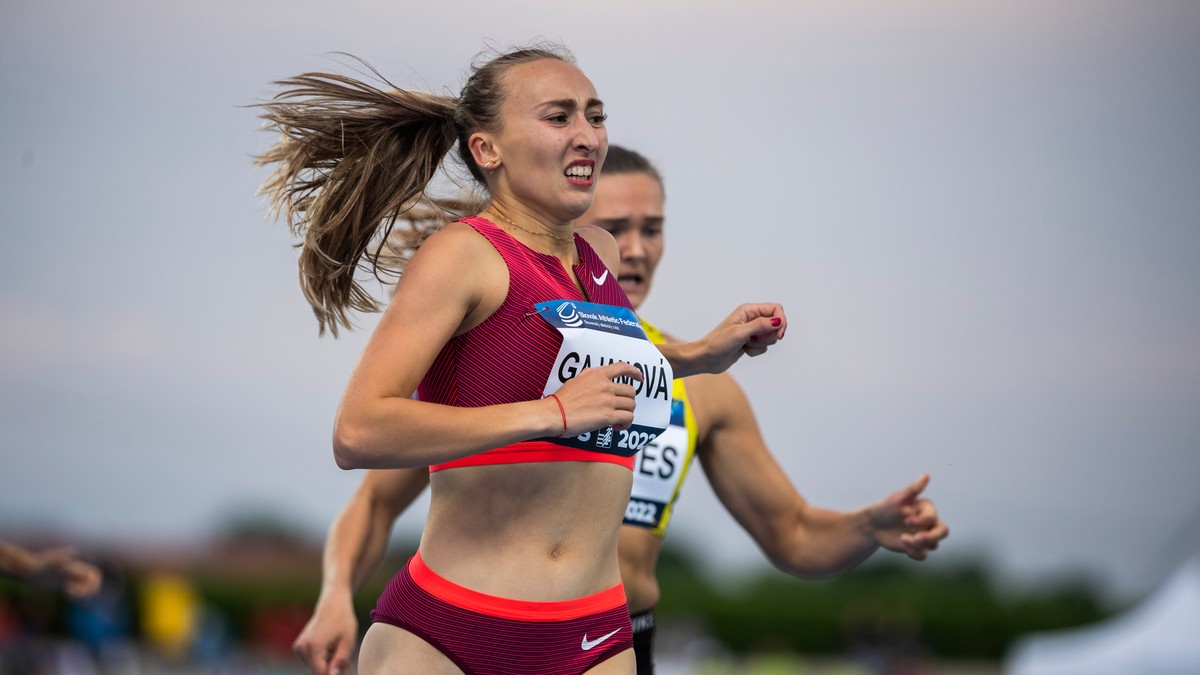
[534,300,671,456]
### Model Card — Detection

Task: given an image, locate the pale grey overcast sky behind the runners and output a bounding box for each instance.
[0,0,1200,593]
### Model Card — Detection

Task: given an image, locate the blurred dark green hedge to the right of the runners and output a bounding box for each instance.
[656,546,1111,659]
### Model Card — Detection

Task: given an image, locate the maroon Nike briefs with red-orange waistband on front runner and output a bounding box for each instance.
[371,551,634,675]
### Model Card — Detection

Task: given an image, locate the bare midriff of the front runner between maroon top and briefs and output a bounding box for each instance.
[421,461,632,602]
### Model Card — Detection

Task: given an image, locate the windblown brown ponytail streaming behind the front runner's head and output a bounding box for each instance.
[257,65,458,335]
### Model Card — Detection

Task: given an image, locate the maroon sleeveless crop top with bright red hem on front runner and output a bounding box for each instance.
[416,217,662,472]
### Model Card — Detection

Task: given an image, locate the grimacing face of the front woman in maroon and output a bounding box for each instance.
[496,59,608,222]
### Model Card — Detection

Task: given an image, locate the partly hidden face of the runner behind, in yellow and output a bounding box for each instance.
[575,173,664,309]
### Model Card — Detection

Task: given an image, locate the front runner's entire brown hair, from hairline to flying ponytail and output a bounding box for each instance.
[254,44,574,336]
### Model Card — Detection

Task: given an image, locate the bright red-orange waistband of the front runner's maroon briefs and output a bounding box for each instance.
[408,551,625,621]
